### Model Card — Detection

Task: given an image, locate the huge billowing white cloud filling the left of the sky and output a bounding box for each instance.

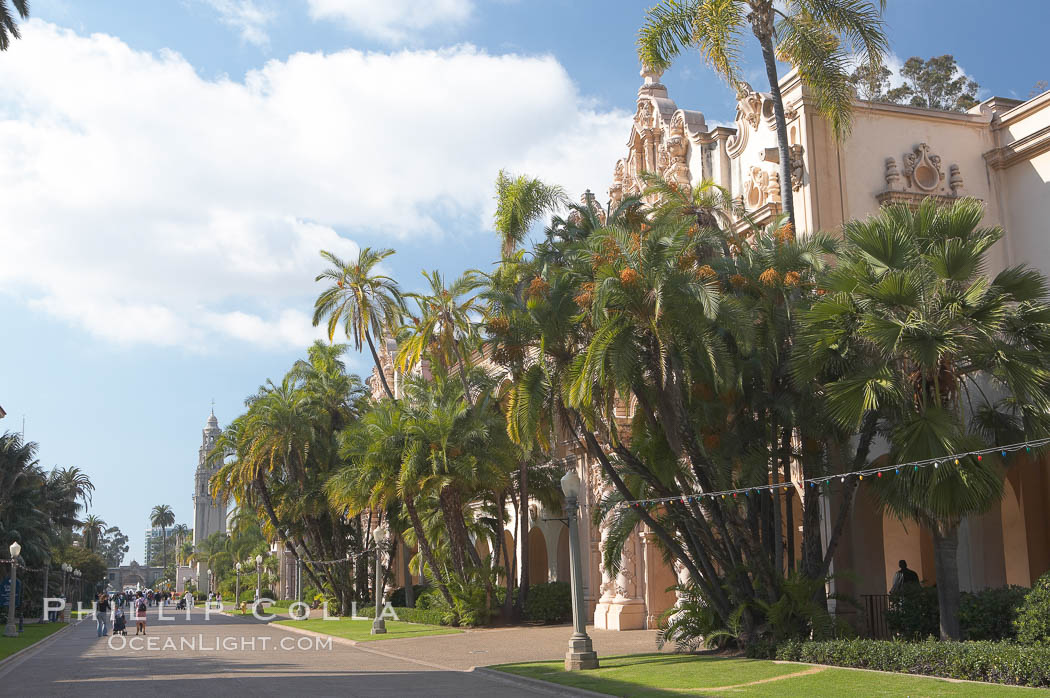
[0,20,630,348]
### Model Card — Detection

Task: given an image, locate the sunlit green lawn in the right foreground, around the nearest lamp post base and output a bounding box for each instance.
[491,654,1047,698]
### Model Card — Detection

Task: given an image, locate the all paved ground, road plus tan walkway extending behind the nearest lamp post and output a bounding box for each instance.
[0,608,654,698]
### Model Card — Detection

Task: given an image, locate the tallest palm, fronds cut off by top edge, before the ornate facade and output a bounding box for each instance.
[638,0,888,227]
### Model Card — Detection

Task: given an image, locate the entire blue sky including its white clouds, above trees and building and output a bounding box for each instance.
[0,0,1050,560]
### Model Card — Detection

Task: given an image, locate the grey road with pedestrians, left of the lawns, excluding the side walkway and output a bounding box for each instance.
[0,608,567,698]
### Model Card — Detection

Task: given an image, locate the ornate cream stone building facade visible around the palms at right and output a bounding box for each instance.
[588,66,1050,629]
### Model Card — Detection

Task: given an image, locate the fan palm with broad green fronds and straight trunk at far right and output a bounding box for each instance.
[800,199,1050,639]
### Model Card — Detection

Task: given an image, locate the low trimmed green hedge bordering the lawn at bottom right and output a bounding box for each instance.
[777,639,1050,689]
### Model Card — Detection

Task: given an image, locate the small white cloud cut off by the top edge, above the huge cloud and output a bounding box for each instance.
[307,0,474,43]
